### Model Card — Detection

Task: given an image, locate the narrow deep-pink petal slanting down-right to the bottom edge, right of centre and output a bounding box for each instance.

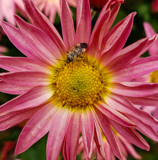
[96,110,122,158]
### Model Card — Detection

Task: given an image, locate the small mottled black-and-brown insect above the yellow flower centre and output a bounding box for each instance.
[66,43,87,63]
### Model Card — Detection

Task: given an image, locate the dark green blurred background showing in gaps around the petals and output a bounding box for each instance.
[0,0,158,160]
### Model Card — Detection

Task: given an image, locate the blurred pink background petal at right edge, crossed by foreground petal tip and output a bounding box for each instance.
[144,22,158,56]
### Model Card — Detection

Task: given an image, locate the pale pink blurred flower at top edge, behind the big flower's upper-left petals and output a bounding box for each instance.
[32,0,76,22]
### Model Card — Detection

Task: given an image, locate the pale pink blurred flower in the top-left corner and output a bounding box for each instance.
[0,0,24,24]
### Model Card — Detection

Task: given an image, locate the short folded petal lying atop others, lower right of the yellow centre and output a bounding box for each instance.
[97,103,135,127]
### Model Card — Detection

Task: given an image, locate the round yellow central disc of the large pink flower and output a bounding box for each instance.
[54,61,105,107]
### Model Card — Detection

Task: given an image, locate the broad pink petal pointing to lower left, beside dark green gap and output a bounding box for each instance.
[15,103,57,155]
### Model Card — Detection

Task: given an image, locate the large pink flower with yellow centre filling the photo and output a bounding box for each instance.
[0,0,158,160]
